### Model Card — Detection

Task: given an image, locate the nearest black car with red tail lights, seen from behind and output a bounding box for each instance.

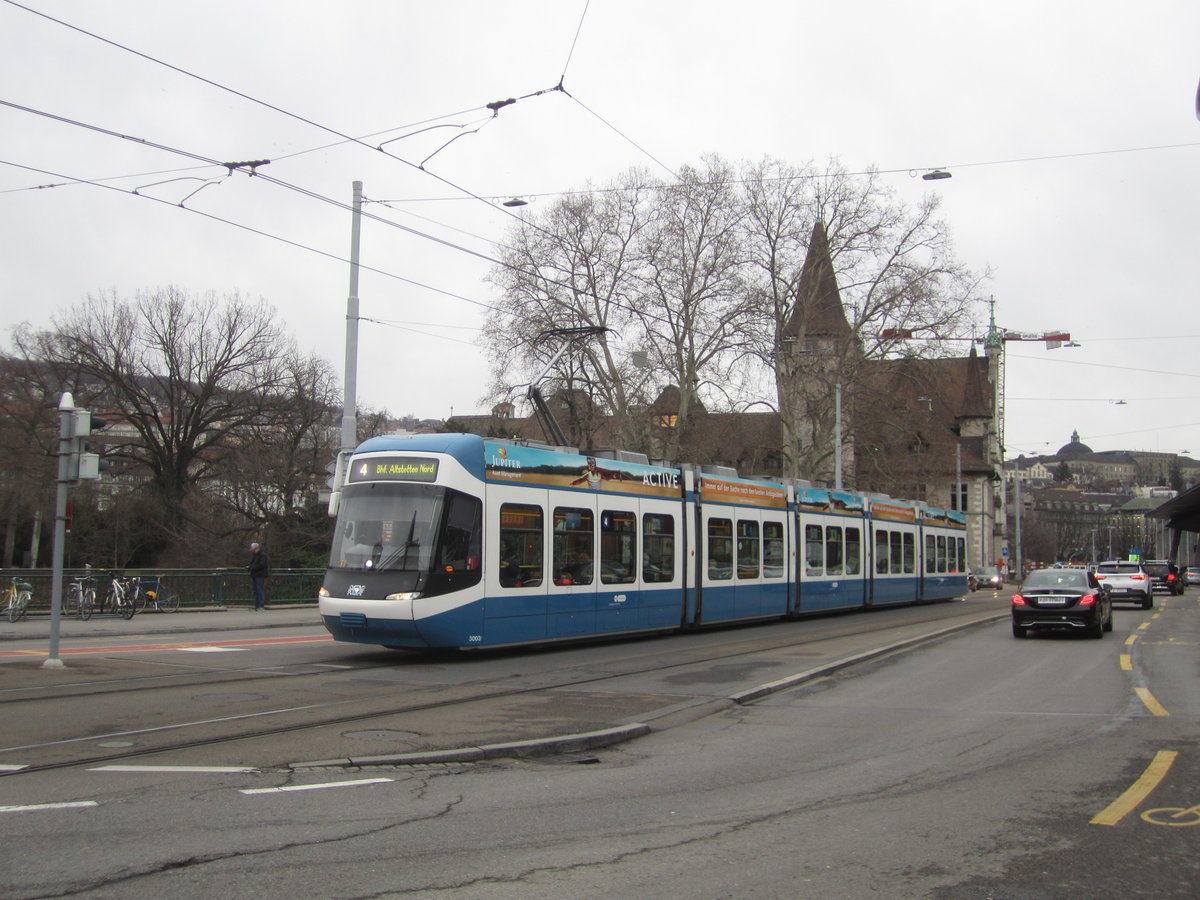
[1013,569,1112,637]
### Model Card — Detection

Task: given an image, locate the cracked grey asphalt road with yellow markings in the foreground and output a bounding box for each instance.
[0,592,1200,899]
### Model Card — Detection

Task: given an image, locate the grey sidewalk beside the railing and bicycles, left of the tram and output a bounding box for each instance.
[0,604,325,642]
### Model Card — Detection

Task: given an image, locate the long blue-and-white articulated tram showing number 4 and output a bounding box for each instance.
[319,434,967,648]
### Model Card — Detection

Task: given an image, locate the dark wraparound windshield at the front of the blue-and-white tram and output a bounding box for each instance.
[329,482,481,572]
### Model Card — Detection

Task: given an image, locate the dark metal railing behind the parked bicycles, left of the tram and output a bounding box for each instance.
[0,569,325,613]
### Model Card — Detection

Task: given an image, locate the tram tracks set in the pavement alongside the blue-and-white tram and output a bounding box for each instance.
[0,605,1003,775]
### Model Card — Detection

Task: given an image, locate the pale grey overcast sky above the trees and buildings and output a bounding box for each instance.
[0,0,1200,458]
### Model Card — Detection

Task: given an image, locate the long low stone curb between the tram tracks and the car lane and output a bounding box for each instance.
[288,612,1010,769]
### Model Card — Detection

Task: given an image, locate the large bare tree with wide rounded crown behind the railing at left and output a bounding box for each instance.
[14,288,329,565]
